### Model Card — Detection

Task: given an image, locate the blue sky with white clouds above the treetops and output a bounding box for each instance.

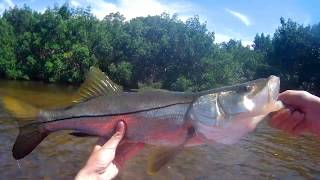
[0,0,320,45]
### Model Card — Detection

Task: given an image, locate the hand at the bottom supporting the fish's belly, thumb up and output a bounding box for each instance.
[75,121,144,180]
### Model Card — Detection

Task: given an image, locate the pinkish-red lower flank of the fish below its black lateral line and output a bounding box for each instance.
[45,115,190,146]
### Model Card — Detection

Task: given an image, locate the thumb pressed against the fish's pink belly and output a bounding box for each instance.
[101,121,125,149]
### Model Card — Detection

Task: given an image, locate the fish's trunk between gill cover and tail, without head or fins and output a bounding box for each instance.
[41,91,194,145]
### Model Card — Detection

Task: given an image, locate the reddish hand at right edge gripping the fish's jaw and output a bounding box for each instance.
[270,90,320,136]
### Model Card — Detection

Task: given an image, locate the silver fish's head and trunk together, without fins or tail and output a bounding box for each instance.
[42,76,279,146]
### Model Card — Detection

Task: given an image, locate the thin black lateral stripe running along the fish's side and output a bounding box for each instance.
[45,101,192,123]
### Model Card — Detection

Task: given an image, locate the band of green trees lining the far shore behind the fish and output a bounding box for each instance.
[0,4,320,95]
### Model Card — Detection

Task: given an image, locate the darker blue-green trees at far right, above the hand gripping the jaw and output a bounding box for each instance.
[255,18,320,94]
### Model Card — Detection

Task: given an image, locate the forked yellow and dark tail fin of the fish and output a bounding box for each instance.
[2,96,49,159]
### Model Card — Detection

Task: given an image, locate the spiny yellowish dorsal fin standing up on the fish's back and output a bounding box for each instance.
[72,67,122,103]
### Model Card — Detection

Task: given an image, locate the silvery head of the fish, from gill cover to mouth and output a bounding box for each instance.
[191,76,283,144]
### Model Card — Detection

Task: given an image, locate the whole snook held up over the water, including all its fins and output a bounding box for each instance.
[2,67,281,173]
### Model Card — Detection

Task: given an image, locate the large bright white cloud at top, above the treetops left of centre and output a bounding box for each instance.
[70,0,194,20]
